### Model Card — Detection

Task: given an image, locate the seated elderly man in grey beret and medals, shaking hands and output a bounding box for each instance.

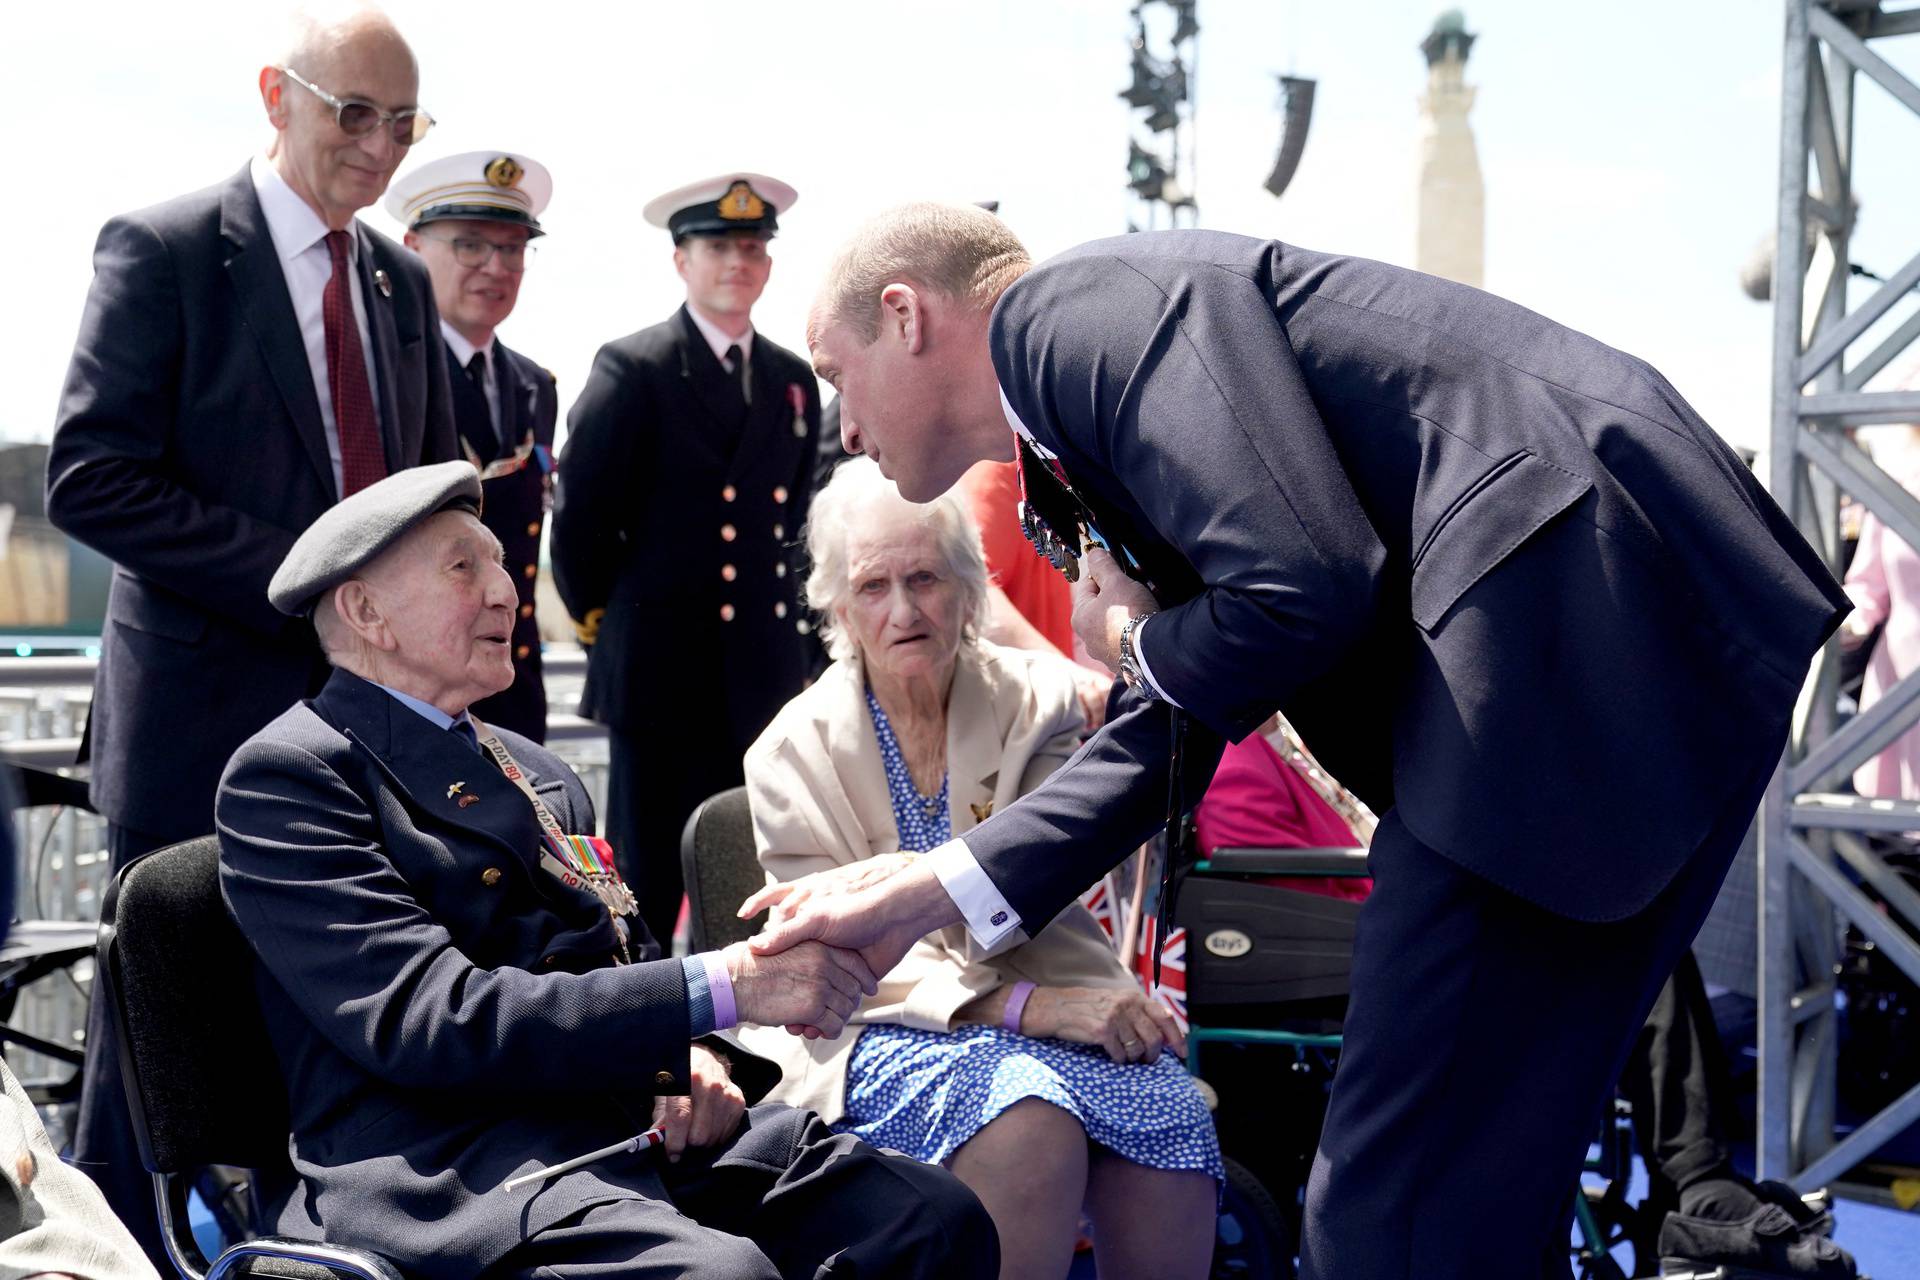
[217,462,998,1280]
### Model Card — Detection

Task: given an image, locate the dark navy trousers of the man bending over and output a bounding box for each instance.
[1300,768,1772,1280]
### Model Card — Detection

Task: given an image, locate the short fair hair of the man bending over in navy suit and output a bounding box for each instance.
[806,201,1033,345]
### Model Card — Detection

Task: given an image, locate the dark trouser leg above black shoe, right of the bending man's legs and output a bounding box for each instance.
[1620,950,1734,1221]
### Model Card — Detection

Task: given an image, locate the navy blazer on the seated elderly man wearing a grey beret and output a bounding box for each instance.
[219,672,780,1280]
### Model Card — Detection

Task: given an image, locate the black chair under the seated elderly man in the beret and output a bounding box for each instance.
[94,837,399,1280]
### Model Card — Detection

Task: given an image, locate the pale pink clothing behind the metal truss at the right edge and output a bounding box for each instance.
[1845,441,1920,800]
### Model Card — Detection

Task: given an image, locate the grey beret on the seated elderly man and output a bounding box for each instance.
[267,462,480,618]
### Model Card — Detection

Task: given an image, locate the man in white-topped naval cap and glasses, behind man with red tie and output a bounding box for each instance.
[386,152,559,743]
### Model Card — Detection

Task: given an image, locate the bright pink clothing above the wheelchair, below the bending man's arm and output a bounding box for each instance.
[1194,733,1373,902]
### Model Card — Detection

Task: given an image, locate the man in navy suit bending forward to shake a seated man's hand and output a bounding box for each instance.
[749,205,1845,1280]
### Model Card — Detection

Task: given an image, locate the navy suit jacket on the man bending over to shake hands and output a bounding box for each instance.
[968,230,1847,919]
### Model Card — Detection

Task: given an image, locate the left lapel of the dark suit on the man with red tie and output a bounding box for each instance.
[221,167,336,493]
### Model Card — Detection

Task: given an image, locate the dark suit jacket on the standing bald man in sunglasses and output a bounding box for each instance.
[46,169,459,841]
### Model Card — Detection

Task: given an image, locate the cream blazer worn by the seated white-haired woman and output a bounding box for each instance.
[739,641,1135,1123]
